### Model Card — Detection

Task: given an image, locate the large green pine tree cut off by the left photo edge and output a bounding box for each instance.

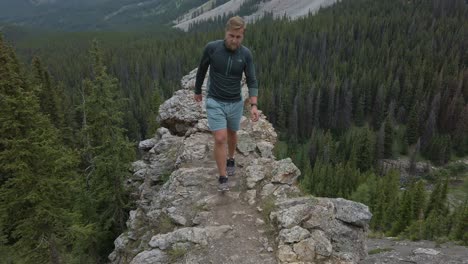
[0,34,81,263]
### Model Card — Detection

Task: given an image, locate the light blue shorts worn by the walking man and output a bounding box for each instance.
[206,97,244,131]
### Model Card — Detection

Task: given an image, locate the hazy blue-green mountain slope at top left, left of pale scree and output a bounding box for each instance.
[0,0,206,31]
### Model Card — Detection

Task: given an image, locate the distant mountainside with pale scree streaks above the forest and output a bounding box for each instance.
[0,0,336,31]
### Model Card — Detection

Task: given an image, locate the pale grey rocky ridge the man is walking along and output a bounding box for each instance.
[109,71,372,264]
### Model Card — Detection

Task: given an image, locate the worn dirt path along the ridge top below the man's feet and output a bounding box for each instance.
[178,160,277,264]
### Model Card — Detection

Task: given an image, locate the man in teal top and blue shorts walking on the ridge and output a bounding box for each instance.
[194,16,259,191]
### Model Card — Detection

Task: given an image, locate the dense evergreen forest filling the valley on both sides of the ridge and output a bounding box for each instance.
[0,0,468,263]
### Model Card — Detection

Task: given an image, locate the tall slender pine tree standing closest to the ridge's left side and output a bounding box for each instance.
[82,40,134,255]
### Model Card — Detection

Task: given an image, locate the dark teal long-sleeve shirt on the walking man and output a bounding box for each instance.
[195,40,258,102]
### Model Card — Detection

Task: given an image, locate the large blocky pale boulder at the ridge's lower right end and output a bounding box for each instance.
[271,197,371,263]
